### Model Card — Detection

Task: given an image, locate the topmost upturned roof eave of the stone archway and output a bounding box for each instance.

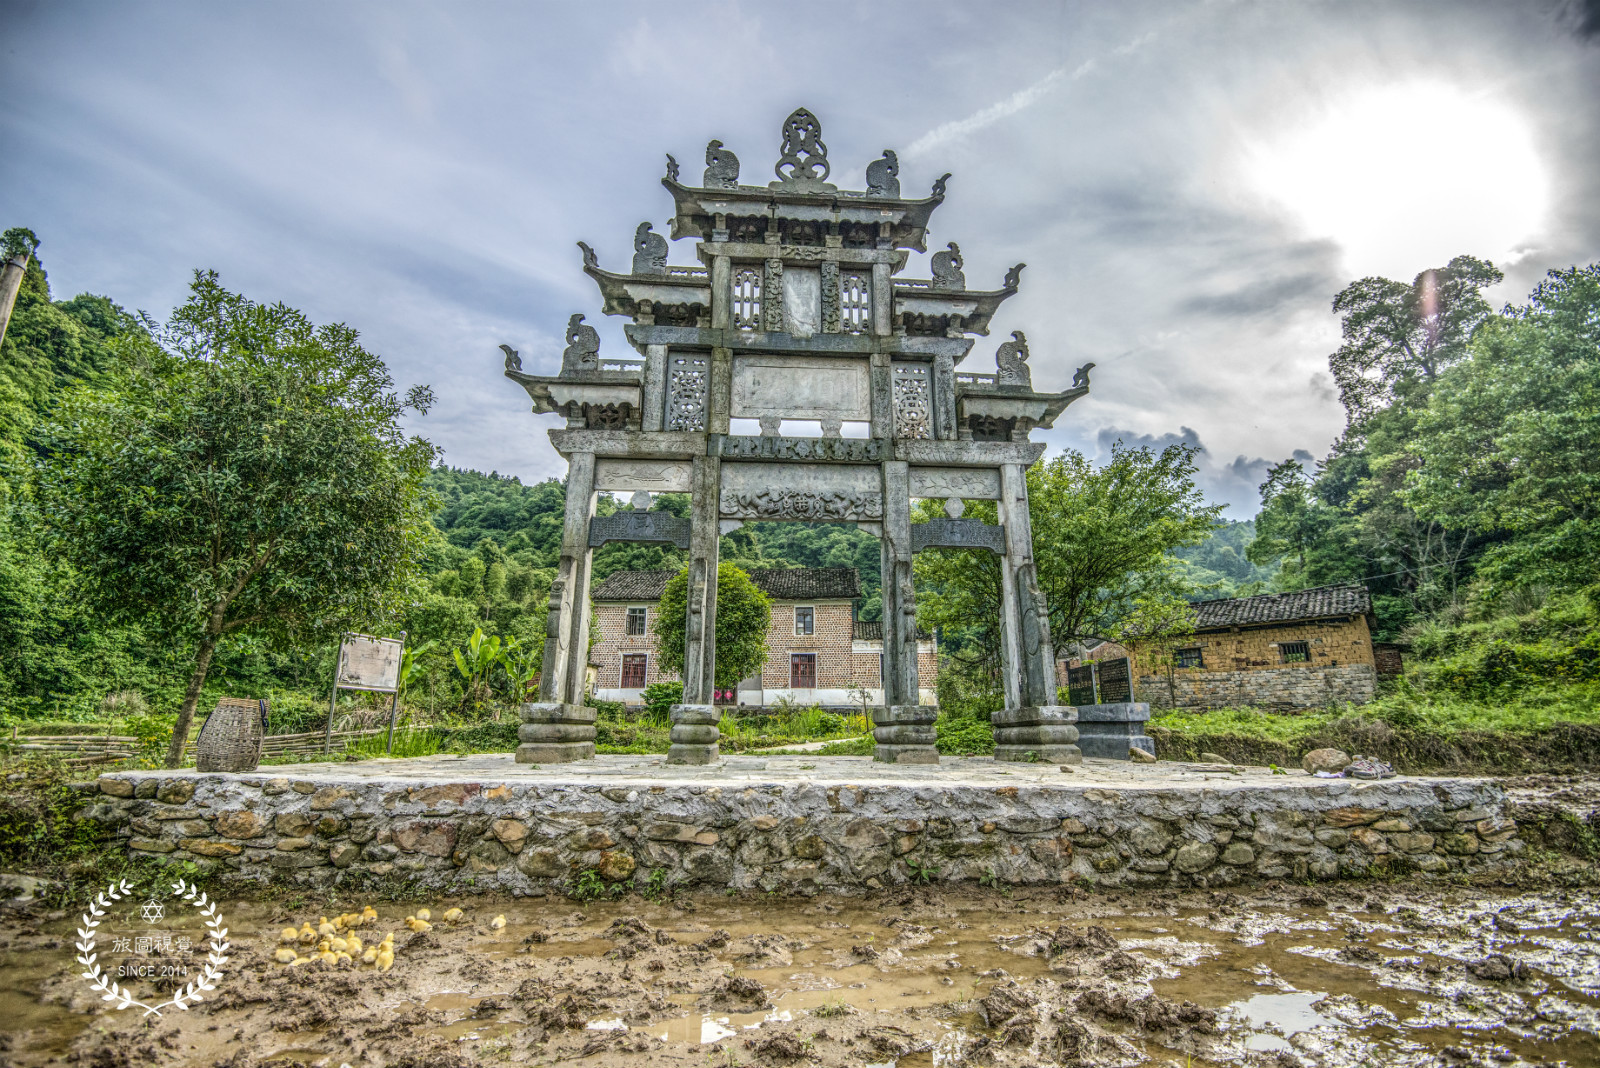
[661,177,944,253]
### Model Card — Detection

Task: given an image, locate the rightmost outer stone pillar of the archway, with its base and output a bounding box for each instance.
[990,464,1083,764]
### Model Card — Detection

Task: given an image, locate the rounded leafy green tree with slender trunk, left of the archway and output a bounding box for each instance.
[40,272,434,766]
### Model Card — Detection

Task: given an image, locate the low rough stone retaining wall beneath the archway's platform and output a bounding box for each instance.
[80,772,1522,895]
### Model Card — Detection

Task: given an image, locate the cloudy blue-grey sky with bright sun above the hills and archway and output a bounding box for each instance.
[0,0,1600,518]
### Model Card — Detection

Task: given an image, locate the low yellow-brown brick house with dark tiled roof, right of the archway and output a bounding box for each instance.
[1062,584,1398,708]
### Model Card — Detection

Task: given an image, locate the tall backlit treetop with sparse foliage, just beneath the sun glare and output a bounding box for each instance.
[1328,256,1504,428]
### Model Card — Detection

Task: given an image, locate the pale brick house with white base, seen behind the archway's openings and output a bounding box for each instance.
[589,568,939,708]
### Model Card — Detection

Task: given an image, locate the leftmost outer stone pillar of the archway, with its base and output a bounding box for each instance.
[517,452,595,764]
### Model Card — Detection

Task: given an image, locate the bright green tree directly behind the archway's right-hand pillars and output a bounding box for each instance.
[915,441,1222,679]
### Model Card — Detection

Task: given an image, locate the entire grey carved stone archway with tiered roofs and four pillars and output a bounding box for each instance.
[506,109,1088,764]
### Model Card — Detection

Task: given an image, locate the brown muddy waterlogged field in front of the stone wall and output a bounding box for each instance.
[0,886,1600,1068]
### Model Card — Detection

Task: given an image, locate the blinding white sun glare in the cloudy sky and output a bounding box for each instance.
[1246,83,1549,280]
